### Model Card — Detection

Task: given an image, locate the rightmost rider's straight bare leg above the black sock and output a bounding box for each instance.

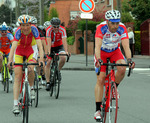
[95,72,106,102]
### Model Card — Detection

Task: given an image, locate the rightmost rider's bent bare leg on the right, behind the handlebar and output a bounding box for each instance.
[115,59,126,84]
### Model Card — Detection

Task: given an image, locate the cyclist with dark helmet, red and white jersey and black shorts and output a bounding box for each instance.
[45,17,68,91]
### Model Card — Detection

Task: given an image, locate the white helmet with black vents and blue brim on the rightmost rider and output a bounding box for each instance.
[105,10,121,22]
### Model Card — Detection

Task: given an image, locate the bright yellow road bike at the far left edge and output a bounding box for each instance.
[1,54,10,93]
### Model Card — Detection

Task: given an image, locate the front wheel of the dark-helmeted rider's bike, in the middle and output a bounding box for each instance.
[54,70,60,99]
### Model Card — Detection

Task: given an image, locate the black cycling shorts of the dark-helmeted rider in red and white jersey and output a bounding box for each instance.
[47,45,65,59]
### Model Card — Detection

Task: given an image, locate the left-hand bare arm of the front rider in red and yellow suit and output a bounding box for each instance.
[9,41,18,63]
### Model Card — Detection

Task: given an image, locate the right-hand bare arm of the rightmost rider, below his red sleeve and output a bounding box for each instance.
[121,39,131,59]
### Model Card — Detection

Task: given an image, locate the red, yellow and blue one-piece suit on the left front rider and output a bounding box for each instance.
[14,25,40,63]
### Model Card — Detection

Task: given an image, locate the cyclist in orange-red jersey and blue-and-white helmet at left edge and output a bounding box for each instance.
[0,22,14,80]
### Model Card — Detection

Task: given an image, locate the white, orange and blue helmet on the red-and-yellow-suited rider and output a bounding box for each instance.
[18,15,31,24]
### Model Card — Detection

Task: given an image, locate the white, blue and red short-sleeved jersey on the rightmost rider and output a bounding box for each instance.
[95,21,129,52]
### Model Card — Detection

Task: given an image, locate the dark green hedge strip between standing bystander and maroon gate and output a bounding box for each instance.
[134,33,141,53]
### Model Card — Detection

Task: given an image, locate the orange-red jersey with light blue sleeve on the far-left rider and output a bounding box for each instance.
[0,32,14,54]
